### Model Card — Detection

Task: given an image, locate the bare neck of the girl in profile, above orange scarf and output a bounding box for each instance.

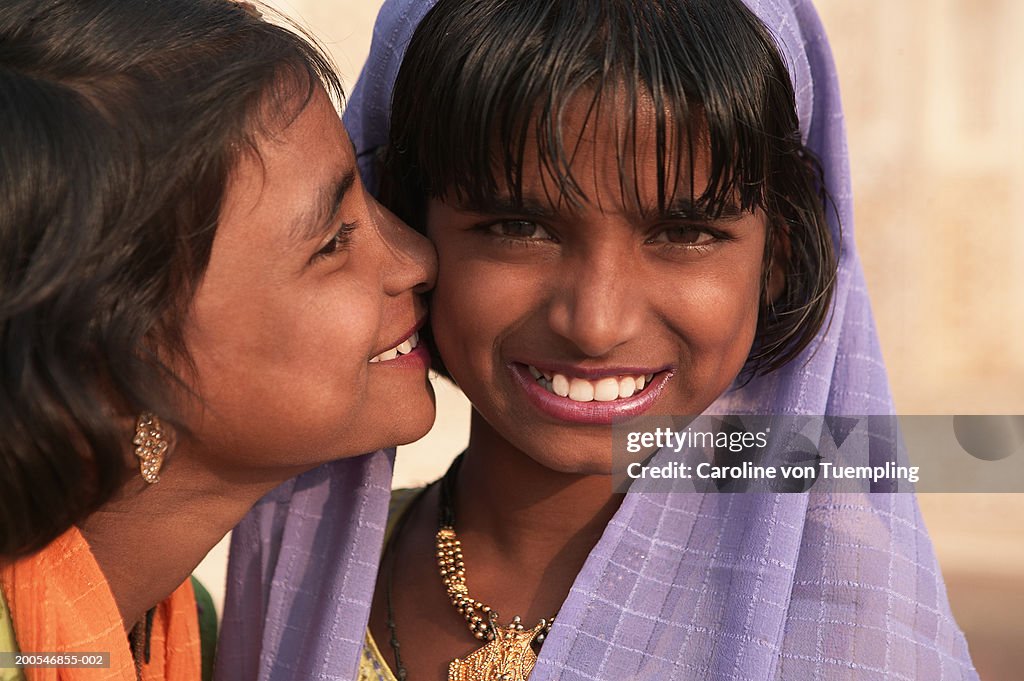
[80,449,298,630]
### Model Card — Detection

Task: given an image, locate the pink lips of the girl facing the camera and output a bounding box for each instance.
[508,361,674,425]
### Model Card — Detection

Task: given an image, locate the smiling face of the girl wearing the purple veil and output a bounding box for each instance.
[427,98,781,473]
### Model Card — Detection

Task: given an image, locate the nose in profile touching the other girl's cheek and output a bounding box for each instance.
[371,195,437,296]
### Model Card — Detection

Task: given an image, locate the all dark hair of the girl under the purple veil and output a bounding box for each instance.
[380,0,838,379]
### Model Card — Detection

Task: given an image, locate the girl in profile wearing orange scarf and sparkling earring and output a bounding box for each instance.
[0,0,436,681]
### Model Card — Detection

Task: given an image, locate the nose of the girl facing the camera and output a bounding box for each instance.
[549,246,644,357]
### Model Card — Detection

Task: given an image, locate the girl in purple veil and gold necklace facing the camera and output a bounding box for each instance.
[218,0,977,681]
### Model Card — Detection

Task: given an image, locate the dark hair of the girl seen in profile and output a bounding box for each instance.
[0,0,342,560]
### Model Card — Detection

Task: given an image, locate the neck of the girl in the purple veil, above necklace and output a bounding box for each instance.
[455,412,622,616]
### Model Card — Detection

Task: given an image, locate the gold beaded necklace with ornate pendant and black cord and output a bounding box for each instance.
[387,455,555,681]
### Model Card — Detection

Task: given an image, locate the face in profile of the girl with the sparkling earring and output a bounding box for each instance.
[185,91,436,467]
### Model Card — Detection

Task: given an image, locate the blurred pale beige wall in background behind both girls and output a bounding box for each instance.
[193,0,1024,681]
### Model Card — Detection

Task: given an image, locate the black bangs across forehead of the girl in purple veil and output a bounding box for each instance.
[384,0,800,226]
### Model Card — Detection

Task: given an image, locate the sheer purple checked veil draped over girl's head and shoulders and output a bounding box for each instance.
[217,0,977,681]
